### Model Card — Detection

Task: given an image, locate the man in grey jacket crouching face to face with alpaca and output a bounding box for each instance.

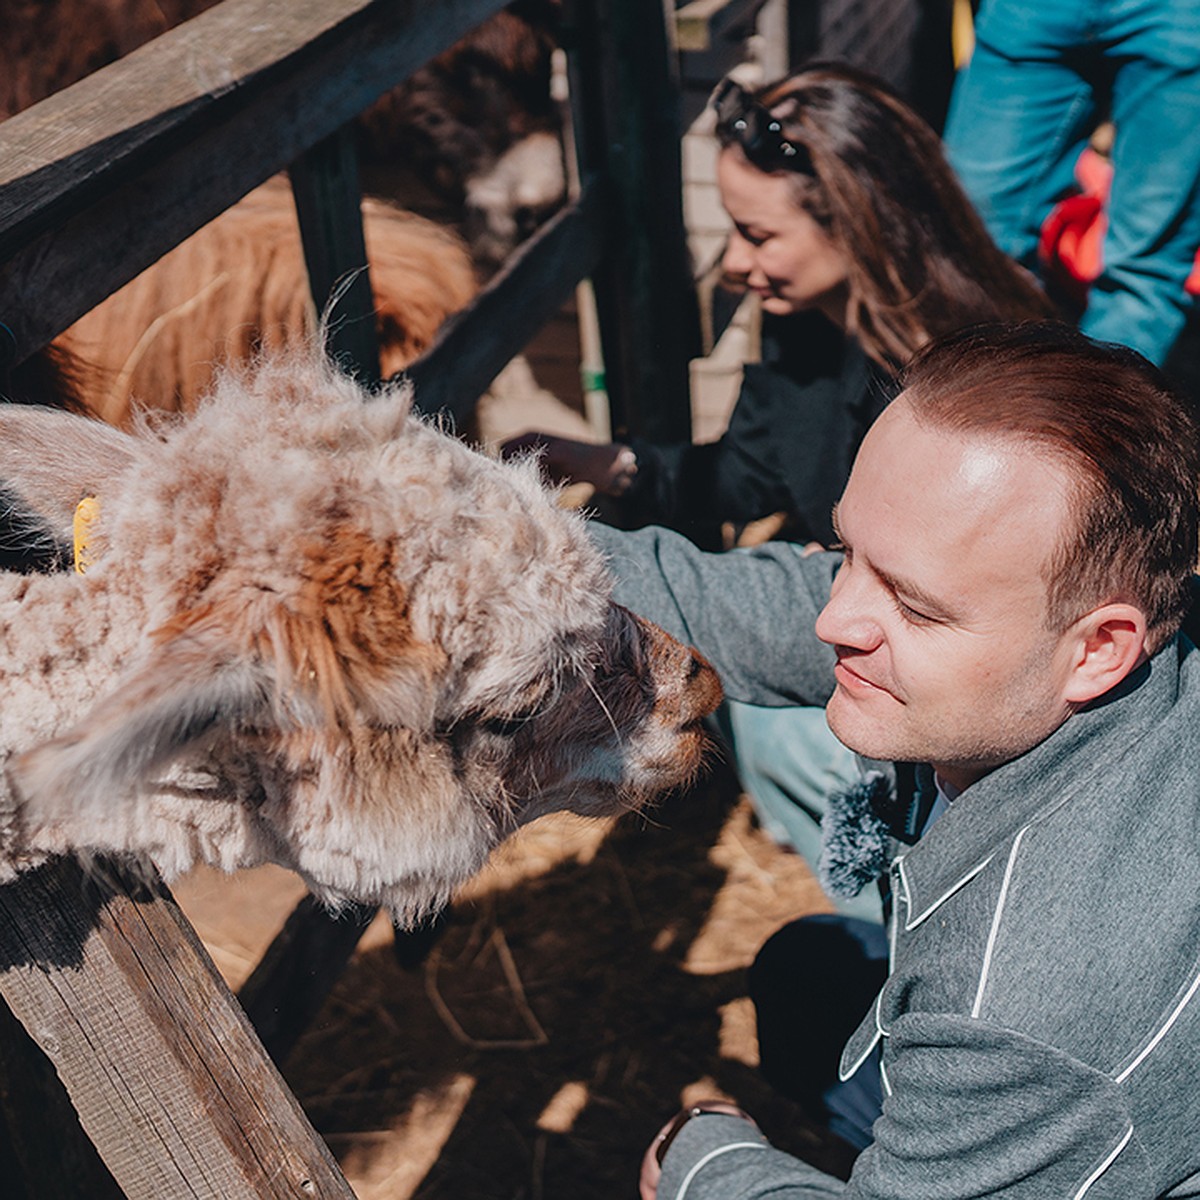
[596,324,1200,1200]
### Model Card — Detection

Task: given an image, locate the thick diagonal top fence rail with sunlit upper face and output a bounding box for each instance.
[0,0,511,362]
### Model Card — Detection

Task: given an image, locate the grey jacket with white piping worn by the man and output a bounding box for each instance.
[595,528,1200,1200]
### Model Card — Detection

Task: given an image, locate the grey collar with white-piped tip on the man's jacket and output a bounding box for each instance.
[895,637,1185,929]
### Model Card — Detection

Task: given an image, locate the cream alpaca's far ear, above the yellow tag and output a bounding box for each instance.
[0,404,137,539]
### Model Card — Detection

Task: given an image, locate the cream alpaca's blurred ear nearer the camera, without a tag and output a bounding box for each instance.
[8,638,271,820]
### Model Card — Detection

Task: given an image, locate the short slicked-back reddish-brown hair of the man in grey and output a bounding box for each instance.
[901,322,1200,653]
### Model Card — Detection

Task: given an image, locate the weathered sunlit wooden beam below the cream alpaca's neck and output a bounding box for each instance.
[0,859,353,1200]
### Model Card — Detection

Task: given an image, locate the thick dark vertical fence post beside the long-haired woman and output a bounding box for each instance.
[562,0,701,443]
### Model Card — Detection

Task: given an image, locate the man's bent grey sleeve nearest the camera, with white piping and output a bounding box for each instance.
[655,1013,1159,1200]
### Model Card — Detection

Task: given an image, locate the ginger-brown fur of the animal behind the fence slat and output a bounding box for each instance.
[55,178,476,427]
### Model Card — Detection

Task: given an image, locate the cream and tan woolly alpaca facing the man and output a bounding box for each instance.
[0,352,720,920]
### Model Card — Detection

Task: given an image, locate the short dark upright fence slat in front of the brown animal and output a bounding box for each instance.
[288,125,379,388]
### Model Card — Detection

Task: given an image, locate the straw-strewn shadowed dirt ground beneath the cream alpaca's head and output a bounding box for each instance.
[175,764,844,1200]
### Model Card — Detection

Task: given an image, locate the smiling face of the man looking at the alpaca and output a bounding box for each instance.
[816,395,1076,787]
